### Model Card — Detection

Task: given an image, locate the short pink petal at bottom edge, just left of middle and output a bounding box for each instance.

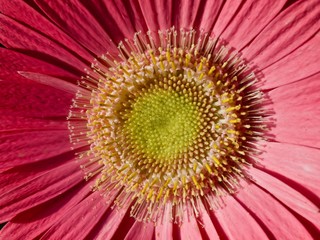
[125,221,155,240]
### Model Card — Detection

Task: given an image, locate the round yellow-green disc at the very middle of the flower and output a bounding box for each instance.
[124,89,201,160]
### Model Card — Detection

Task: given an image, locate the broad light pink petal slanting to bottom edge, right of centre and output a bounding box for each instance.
[214,196,269,240]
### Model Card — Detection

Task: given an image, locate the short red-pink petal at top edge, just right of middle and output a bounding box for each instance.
[172,0,201,29]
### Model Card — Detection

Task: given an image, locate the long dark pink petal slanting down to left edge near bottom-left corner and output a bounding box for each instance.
[0,161,83,222]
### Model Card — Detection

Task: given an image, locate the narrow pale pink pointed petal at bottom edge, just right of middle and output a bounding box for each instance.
[180,204,202,240]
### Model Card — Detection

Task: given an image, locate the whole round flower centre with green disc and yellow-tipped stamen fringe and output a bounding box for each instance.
[70,29,264,221]
